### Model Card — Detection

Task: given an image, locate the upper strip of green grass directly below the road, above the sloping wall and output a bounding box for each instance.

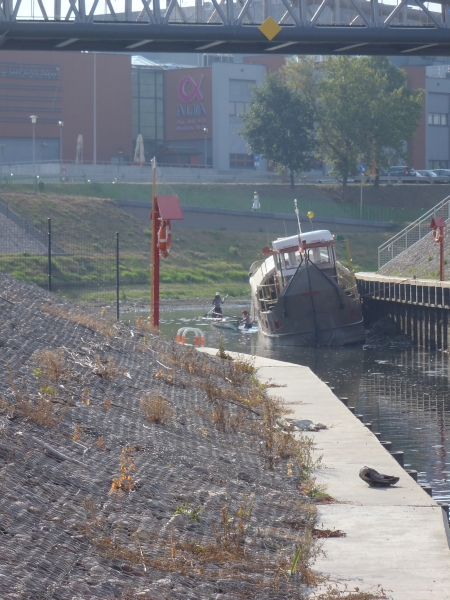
[0,182,430,226]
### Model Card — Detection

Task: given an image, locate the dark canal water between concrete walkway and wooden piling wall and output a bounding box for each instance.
[122,305,450,502]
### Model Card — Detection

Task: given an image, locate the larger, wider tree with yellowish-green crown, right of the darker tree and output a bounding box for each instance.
[285,56,423,197]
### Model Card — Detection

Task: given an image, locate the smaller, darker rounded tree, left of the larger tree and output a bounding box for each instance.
[239,73,314,187]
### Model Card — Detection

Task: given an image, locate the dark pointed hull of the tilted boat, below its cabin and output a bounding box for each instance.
[253,264,365,346]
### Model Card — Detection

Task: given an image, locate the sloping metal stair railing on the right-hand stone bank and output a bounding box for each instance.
[378,196,450,269]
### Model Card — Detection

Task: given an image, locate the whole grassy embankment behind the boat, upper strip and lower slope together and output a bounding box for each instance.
[0,179,448,299]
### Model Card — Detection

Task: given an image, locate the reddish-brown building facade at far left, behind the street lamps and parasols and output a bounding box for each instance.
[0,51,133,164]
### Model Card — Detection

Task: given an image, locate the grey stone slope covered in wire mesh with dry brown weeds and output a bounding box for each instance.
[0,275,314,600]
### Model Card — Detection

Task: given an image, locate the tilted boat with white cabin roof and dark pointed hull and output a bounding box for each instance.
[250,227,365,346]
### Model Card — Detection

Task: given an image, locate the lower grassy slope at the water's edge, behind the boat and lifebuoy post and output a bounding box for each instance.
[0,193,404,301]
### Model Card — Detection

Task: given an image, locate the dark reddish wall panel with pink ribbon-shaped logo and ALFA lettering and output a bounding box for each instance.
[166,68,212,140]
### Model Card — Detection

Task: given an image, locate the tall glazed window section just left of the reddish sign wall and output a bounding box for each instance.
[132,67,164,161]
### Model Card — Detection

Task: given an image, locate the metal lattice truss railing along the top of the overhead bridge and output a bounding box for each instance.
[0,0,447,27]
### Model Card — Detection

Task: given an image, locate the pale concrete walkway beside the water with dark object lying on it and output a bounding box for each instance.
[205,349,450,600]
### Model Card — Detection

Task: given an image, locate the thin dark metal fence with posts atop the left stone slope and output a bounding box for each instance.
[0,204,120,318]
